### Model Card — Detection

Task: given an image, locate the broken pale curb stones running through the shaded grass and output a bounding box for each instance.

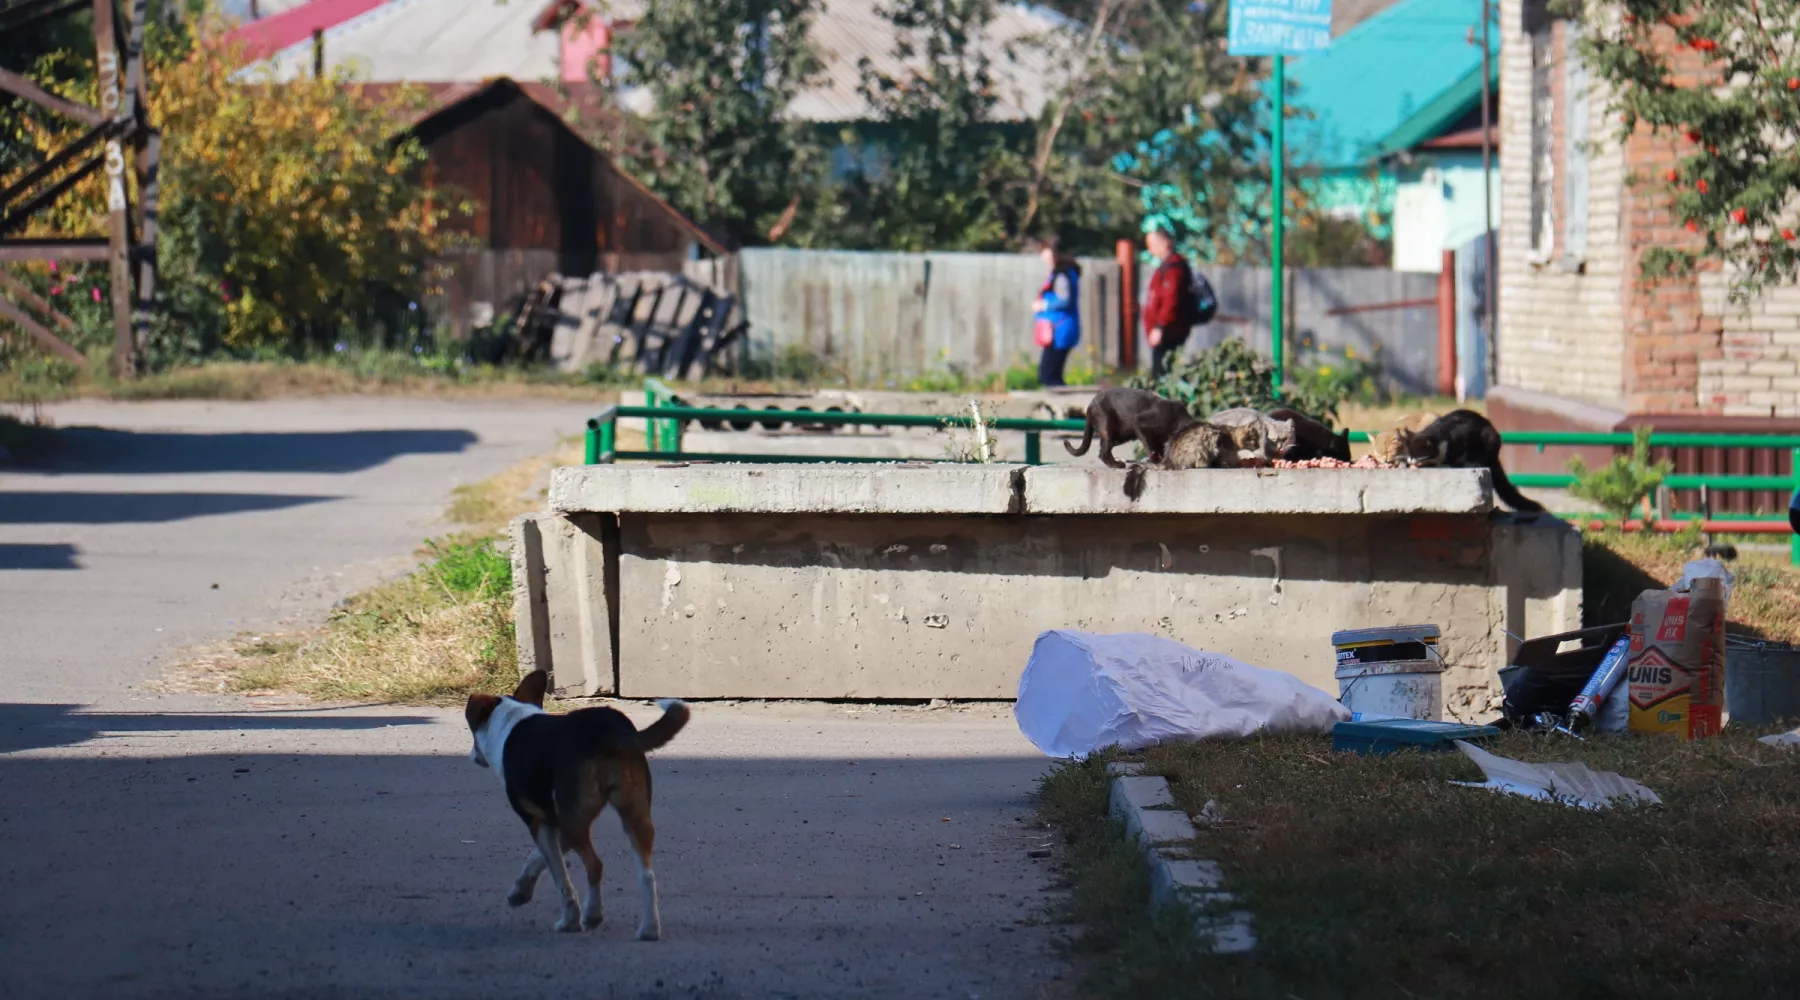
[1107,764,1256,955]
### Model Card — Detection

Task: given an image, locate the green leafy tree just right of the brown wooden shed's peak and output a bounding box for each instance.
[610,0,823,245]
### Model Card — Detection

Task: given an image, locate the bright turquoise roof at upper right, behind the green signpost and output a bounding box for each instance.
[1289,0,1499,169]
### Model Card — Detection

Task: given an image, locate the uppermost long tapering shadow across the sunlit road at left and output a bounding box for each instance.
[40,426,477,475]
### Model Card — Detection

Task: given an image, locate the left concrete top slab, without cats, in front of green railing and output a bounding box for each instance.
[549,464,1024,516]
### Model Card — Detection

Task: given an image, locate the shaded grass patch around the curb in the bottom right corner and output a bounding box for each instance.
[1039,732,1800,1000]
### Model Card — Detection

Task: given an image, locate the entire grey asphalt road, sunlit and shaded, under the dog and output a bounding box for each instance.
[0,399,1067,998]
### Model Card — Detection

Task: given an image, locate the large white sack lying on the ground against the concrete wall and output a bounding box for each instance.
[1013,629,1350,757]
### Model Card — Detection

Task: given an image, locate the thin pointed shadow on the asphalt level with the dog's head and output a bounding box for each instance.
[0,703,434,754]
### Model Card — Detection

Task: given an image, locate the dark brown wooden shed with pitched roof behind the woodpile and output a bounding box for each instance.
[412,77,725,335]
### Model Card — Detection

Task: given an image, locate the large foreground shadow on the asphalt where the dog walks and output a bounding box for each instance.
[0,744,1064,1000]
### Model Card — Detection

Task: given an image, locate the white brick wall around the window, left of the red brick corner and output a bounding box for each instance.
[1499,0,1625,406]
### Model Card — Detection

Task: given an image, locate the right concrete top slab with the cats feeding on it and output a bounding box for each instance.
[1024,466,1494,514]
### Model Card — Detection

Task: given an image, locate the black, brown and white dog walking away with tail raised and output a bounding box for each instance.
[463,671,688,941]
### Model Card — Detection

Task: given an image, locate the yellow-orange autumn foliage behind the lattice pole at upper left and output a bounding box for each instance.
[0,18,452,354]
